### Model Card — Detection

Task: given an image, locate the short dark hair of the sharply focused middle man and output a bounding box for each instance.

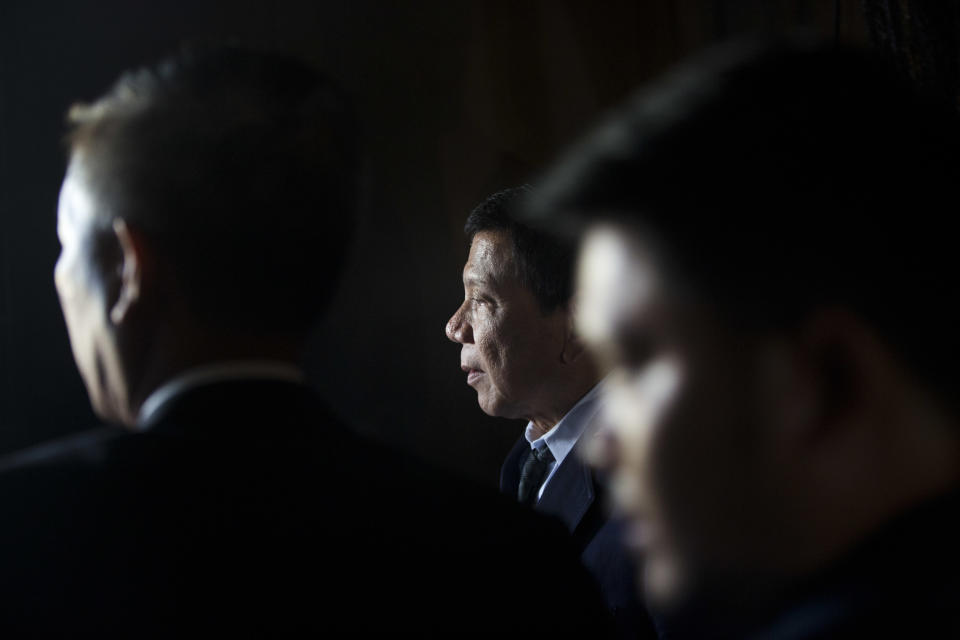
[463,186,575,313]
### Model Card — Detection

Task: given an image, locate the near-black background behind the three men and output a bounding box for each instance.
[0,0,866,485]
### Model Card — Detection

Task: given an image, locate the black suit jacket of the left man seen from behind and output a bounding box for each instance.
[0,381,606,637]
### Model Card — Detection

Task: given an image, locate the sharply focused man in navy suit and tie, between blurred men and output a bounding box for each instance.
[446,188,652,637]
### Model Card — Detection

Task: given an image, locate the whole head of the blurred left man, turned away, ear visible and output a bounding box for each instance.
[56,46,356,424]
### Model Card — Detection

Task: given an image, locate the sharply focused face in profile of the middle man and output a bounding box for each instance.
[446,231,567,419]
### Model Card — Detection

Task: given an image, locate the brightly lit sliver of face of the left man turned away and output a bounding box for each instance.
[54,154,121,420]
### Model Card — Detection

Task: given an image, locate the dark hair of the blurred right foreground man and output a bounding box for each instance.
[525,42,960,404]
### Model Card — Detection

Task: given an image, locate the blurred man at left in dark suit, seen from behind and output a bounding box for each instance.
[0,43,605,637]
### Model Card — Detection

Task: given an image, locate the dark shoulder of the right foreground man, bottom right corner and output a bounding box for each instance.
[744,490,960,640]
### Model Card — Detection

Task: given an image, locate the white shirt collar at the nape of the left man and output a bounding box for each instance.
[137,360,304,429]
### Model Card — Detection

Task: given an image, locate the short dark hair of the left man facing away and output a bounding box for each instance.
[69,46,356,334]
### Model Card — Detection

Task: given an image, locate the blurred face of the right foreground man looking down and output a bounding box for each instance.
[576,226,776,610]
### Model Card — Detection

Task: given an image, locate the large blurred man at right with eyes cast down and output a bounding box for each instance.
[525,43,960,640]
